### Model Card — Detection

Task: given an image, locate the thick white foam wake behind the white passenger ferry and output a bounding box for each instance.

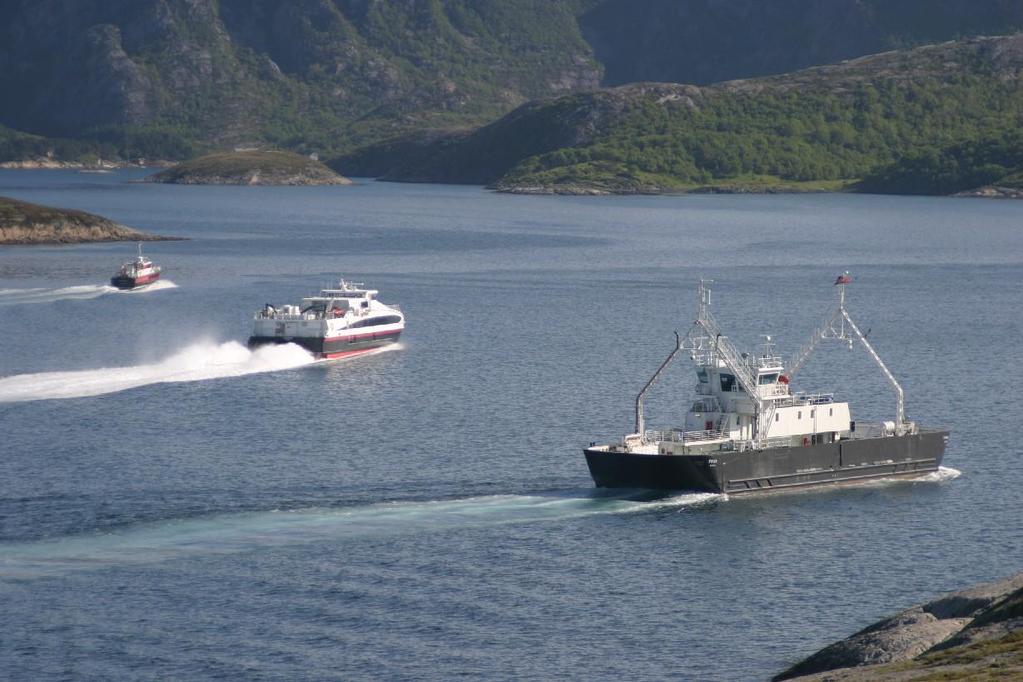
[0,342,315,403]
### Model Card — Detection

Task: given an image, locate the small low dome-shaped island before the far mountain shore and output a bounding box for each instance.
[145,151,352,185]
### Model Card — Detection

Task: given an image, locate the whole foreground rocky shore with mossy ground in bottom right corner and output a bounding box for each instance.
[773,573,1023,682]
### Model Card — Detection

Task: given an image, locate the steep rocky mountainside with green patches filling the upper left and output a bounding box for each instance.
[0,0,601,155]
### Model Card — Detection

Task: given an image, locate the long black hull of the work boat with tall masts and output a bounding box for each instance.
[585,429,948,495]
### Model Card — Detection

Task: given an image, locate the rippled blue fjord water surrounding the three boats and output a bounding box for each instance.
[0,171,1023,680]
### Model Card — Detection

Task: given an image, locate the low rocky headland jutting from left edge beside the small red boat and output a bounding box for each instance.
[0,196,177,244]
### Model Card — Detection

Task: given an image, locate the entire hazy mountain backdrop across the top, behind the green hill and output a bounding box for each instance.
[6,0,1023,160]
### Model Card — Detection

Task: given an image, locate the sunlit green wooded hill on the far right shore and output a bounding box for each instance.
[333,34,1023,192]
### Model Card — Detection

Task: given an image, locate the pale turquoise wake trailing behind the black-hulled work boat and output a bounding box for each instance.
[0,490,726,579]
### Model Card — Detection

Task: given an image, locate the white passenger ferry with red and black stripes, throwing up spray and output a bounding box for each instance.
[249,279,405,359]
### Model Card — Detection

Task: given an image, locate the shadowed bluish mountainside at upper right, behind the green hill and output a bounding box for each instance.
[580,0,1023,85]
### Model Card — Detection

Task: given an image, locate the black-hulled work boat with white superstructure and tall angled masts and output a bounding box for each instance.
[585,273,948,494]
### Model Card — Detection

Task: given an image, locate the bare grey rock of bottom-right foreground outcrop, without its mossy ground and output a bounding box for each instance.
[774,573,1023,682]
